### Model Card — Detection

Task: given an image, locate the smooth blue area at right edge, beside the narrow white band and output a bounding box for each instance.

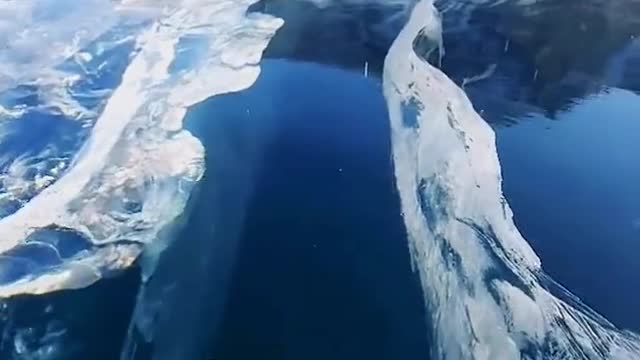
[497,89,640,331]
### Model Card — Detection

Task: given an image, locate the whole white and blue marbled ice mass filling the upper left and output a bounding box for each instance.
[0,0,282,296]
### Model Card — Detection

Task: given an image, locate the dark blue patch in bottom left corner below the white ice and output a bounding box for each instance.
[0,268,140,360]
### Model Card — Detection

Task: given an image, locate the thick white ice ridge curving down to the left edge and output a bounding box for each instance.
[0,0,282,296]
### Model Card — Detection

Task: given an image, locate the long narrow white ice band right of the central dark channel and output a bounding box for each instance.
[384,0,640,360]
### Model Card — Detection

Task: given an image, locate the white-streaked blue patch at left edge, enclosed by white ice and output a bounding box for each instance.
[0,25,134,218]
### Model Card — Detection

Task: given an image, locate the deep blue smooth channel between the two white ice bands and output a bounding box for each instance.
[178,60,428,359]
